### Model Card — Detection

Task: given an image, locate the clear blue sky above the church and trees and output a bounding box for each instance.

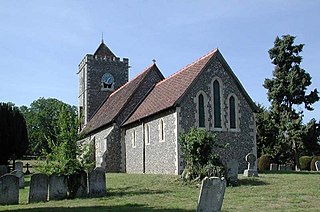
[0,0,320,122]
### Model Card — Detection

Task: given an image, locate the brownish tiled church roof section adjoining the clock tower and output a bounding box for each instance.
[83,64,162,134]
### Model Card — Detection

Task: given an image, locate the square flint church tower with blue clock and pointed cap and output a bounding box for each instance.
[78,41,129,128]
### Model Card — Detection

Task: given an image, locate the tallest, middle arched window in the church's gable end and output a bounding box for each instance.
[213,80,221,128]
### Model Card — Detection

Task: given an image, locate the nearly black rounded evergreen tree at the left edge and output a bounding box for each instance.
[0,103,28,164]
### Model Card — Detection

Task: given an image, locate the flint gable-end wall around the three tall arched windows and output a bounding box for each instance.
[178,57,256,172]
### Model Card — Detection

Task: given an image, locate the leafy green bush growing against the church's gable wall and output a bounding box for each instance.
[179,127,224,181]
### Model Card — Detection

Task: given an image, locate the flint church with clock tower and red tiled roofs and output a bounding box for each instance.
[78,41,257,174]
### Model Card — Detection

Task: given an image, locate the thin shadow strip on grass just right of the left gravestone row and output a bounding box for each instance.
[107,186,171,197]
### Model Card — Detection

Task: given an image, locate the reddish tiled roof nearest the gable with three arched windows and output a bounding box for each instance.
[124,49,218,125]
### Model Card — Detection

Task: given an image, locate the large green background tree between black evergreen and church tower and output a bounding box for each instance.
[20,98,77,155]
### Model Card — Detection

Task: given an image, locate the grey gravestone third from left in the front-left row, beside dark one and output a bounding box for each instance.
[49,175,68,200]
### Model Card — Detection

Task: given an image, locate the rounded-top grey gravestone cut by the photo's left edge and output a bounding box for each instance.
[0,174,19,205]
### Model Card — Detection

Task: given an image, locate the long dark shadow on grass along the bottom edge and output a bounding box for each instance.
[14,204,194,212]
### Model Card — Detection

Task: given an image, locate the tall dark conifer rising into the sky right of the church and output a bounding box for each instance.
[263,35,319,168]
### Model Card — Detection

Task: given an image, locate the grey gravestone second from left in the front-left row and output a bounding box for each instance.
[29,173,49,203]
